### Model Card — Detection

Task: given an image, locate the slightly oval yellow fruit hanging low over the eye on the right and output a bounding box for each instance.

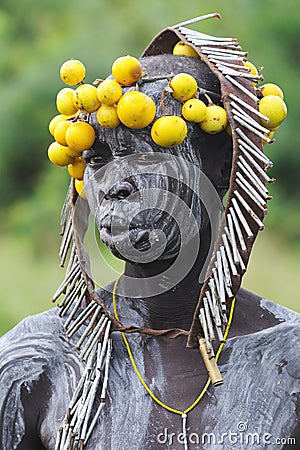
[151,116,188,148]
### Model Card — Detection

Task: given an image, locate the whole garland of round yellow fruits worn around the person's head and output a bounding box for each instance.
[48,41,287,197]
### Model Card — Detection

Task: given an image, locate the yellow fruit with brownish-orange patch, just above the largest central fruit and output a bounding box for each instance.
[111,55,143,86]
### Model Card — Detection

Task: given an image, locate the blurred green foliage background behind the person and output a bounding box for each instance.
[0,0,300,334]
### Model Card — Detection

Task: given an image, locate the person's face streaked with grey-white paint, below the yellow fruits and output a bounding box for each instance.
[85,134,201,262]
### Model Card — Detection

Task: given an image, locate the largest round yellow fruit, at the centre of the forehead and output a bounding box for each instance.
[117,91,156,129]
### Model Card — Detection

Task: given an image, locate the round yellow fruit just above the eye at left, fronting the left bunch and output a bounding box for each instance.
[66,122,96,152]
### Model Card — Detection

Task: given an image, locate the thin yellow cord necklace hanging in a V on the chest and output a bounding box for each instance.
[112,274,235,450]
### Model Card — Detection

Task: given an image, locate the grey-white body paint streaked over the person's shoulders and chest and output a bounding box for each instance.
[0,294,300,450]
